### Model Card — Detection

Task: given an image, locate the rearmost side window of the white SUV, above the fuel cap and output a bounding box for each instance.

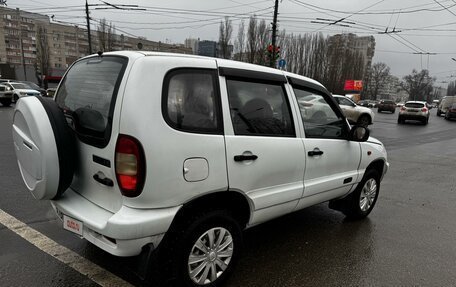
[162,69,222,134]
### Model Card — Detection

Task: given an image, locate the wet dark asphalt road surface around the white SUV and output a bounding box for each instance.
[0,107,456,287]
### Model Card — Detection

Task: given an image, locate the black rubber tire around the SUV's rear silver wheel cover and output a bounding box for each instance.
[157,210,242,287]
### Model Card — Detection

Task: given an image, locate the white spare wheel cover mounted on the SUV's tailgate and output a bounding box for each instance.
[13,97,76,199]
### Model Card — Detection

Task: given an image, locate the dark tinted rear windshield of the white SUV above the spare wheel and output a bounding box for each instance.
[55,56,128,147]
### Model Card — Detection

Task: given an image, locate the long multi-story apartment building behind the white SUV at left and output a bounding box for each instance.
[0,7,192,82]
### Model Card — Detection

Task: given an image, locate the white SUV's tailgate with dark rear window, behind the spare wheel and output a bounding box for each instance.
[55,55,131,212]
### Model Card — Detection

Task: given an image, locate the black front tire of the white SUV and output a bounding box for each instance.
[340,169,380,220]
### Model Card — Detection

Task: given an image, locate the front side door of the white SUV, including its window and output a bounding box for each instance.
[292,81,361,207]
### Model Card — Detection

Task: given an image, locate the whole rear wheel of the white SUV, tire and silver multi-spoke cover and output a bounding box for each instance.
[160,210,242,287]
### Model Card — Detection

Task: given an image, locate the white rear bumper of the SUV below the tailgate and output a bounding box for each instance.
[51,189,180,256]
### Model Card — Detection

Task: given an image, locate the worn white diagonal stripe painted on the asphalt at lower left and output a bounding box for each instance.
[0,209,133,286]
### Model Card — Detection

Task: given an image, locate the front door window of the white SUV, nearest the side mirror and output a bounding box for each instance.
[293,87,347,139]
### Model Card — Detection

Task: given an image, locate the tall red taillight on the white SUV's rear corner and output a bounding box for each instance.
[116,135,146,197]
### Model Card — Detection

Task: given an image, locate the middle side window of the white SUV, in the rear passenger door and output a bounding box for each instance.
[226,78,295,137]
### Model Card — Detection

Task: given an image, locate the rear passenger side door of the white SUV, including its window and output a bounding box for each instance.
[220,68,306,223]
